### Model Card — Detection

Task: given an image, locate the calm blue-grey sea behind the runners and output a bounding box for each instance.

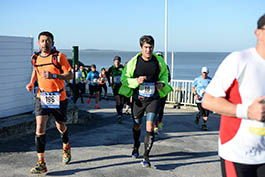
[60,49,229,80]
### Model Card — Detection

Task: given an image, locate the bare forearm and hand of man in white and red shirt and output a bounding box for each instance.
[202,93,265,121]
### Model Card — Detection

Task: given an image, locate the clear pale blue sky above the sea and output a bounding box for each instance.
[0,0,265,52]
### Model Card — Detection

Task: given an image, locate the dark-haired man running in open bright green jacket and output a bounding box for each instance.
[119,36,172,167]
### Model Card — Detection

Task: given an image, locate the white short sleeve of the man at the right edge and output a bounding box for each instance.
[206,53,239,97]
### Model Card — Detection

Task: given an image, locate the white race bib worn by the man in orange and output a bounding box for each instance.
[40,92,60,109]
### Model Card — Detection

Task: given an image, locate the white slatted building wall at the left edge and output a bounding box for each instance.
[0,36,34,118]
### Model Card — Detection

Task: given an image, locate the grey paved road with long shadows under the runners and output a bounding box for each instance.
[0,101,221,177]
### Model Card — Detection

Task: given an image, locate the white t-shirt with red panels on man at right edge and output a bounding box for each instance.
[206,48,265,164]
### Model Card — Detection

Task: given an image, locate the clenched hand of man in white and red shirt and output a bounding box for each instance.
[248,96,265,122]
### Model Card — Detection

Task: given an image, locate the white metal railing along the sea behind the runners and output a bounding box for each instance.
[167,80,196,106]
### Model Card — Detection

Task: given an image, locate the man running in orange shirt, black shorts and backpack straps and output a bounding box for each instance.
[26,31,73,174]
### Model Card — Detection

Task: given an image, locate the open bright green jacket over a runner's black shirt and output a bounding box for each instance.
[119,53,173,98]
